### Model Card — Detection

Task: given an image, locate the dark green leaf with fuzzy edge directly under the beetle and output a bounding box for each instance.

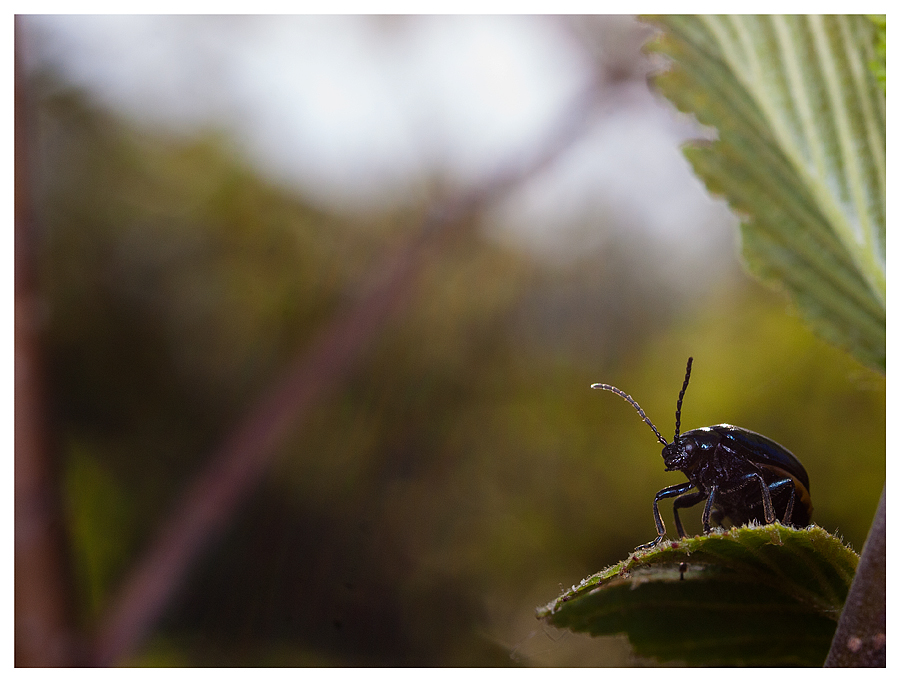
[537,523,859,666]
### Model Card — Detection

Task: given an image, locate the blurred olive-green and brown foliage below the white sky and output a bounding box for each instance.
[33,75,885,666]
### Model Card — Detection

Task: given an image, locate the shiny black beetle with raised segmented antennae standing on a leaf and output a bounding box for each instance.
[591,358,812,549]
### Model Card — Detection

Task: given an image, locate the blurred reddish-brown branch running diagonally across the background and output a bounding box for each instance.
[93,79,598,665]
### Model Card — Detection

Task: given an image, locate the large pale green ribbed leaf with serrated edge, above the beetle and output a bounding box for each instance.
[650,16,885,373]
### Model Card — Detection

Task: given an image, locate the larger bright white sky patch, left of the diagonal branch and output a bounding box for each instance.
[22,16,587,205]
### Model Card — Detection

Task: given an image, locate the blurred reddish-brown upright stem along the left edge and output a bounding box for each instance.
[14,17,79,667]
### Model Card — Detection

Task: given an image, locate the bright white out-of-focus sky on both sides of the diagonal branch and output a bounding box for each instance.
[26,15,733,276]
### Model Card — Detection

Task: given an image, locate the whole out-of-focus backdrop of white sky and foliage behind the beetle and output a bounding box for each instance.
[16,16,886,666]
